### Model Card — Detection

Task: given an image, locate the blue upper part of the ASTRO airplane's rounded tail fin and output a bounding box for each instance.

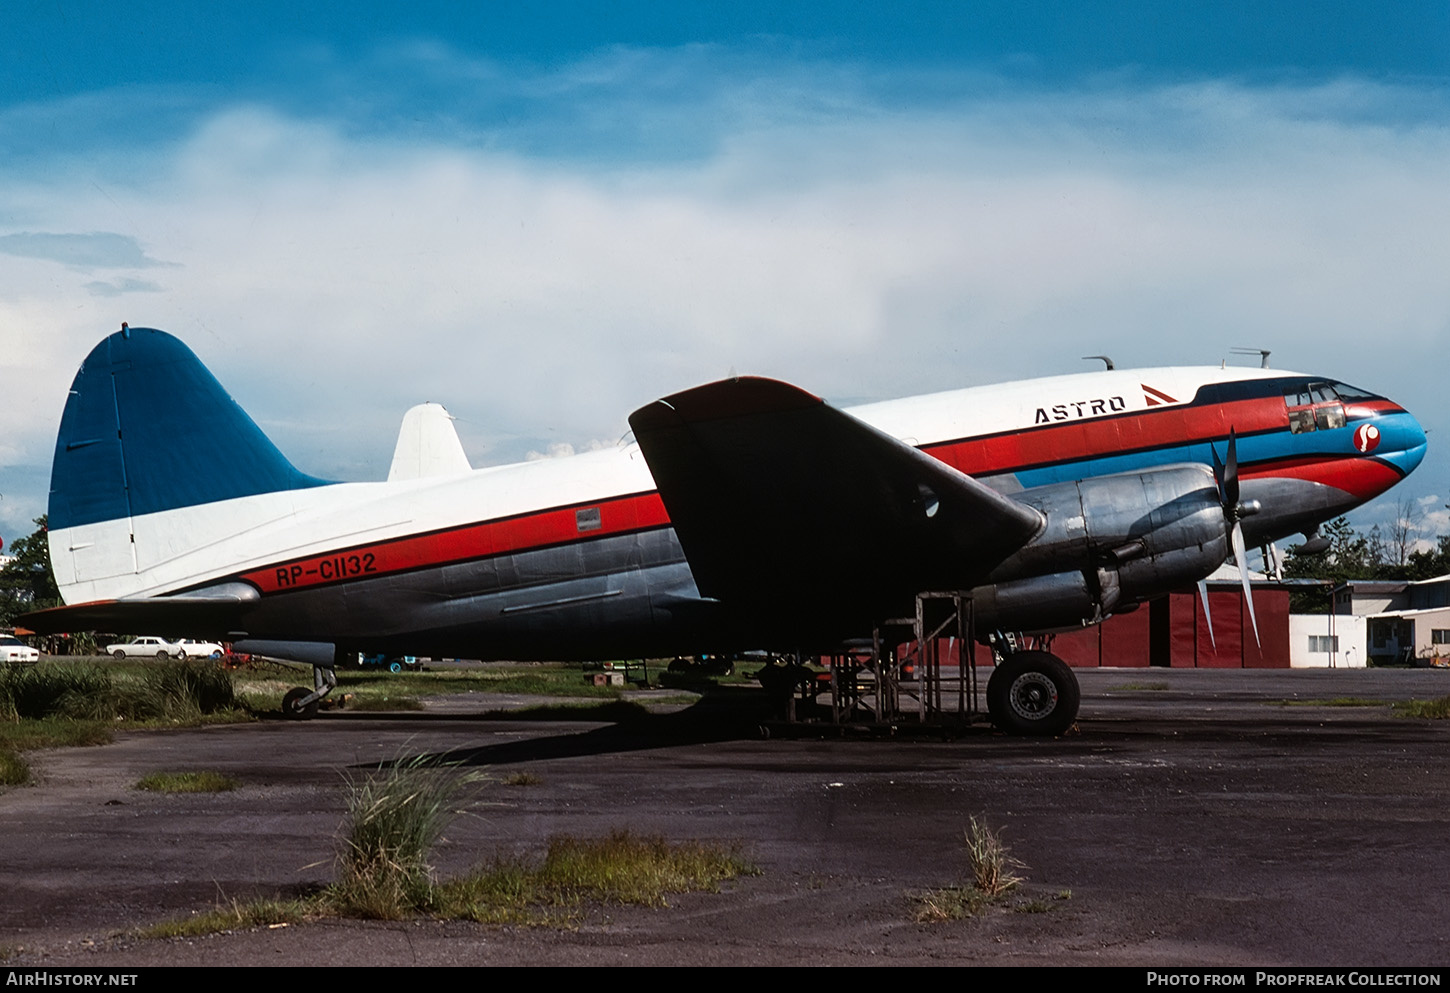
[49,328,326,529]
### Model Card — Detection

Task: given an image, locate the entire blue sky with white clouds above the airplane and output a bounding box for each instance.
[0,0,1450,542]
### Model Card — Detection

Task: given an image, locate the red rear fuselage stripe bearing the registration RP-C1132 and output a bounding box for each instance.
[241,493,670,593]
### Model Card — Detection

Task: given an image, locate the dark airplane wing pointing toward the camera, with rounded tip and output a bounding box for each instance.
[629,377,1044,612]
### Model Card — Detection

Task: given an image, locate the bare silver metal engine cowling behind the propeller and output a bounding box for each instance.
[972,465,1230,631]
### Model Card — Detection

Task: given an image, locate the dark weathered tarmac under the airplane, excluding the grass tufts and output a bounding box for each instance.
[0,670,1450,967]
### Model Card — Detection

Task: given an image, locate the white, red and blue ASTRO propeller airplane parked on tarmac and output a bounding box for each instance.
[23,325,1425,735]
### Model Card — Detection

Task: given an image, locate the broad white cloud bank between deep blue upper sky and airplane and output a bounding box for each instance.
[0,68,1450,539]
